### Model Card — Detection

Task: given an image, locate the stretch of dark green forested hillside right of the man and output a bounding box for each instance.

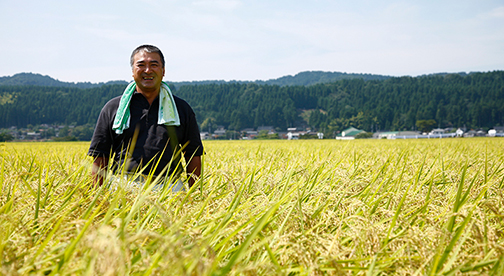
[177,71,504,131]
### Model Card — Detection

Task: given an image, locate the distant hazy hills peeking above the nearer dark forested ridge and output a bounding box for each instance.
[0,71,390,88]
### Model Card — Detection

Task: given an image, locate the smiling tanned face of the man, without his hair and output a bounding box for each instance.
[132,51,165,93]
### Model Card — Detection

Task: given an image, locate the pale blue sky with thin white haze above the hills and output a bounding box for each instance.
[0,0,504,82]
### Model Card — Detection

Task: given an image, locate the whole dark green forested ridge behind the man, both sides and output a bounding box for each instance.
[0,71,504,132]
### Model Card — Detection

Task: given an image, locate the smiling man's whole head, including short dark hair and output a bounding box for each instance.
[130,45,165,95]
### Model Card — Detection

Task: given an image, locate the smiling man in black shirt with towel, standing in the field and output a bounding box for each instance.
[88,45,203,189]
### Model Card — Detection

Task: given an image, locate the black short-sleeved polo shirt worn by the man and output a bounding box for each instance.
[88,92,203,175]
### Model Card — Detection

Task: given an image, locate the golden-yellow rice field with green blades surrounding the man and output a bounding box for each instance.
[0,138,504,275]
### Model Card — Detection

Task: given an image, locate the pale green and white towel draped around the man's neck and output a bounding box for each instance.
[112,82,180,134]
